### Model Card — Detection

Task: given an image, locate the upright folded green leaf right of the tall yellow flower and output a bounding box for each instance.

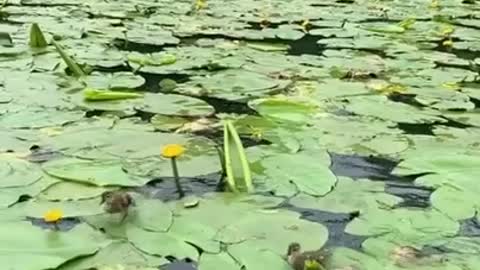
[223,120,254,192]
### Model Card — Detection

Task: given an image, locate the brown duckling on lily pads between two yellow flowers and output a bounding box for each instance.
[100,191,135,223]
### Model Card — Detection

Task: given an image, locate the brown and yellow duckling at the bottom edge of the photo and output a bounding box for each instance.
[287,242,326,270]
